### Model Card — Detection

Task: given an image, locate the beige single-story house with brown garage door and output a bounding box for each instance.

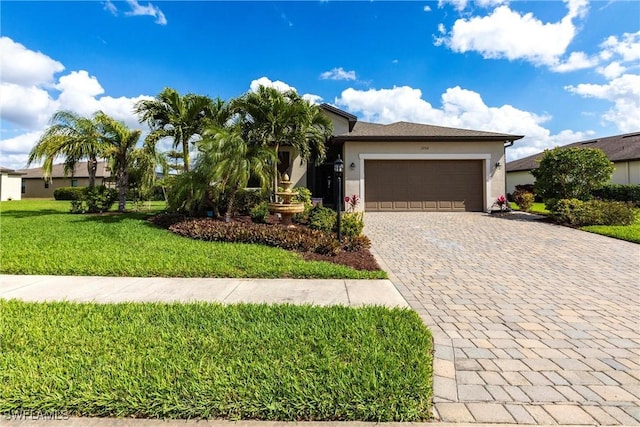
[283,104,523,212]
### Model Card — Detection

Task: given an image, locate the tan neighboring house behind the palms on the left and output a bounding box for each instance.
[20,162,111,199]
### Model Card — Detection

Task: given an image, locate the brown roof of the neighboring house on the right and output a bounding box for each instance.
[506,132,640,172]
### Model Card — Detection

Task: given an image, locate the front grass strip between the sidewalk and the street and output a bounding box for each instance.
[0,300,432,421]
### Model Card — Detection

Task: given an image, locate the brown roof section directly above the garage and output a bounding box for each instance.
[334,122,523,141]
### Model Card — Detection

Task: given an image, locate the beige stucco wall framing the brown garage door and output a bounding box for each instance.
[344,141,505,210]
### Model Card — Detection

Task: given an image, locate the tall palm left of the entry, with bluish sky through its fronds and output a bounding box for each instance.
[134,87,218,172]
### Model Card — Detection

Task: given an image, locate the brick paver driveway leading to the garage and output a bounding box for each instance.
[365,213,640,425]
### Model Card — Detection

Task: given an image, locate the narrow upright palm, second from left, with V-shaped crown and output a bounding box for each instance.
[95,111,141,212]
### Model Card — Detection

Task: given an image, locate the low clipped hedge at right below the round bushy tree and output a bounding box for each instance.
[552,199,635,227]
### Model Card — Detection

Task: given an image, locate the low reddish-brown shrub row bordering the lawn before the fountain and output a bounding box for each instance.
[169,218,340,255]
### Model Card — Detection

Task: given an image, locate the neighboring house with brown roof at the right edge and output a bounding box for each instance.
[507,132,640,193]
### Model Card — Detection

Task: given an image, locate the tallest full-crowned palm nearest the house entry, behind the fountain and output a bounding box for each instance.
[232,86,333,199]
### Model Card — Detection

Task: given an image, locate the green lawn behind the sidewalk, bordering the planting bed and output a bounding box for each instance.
[0,200,386,279]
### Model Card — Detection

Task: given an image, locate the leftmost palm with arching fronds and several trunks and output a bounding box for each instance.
[27,111,105,187]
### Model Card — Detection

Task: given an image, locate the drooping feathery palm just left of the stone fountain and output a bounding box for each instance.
[196,125,277,218]
